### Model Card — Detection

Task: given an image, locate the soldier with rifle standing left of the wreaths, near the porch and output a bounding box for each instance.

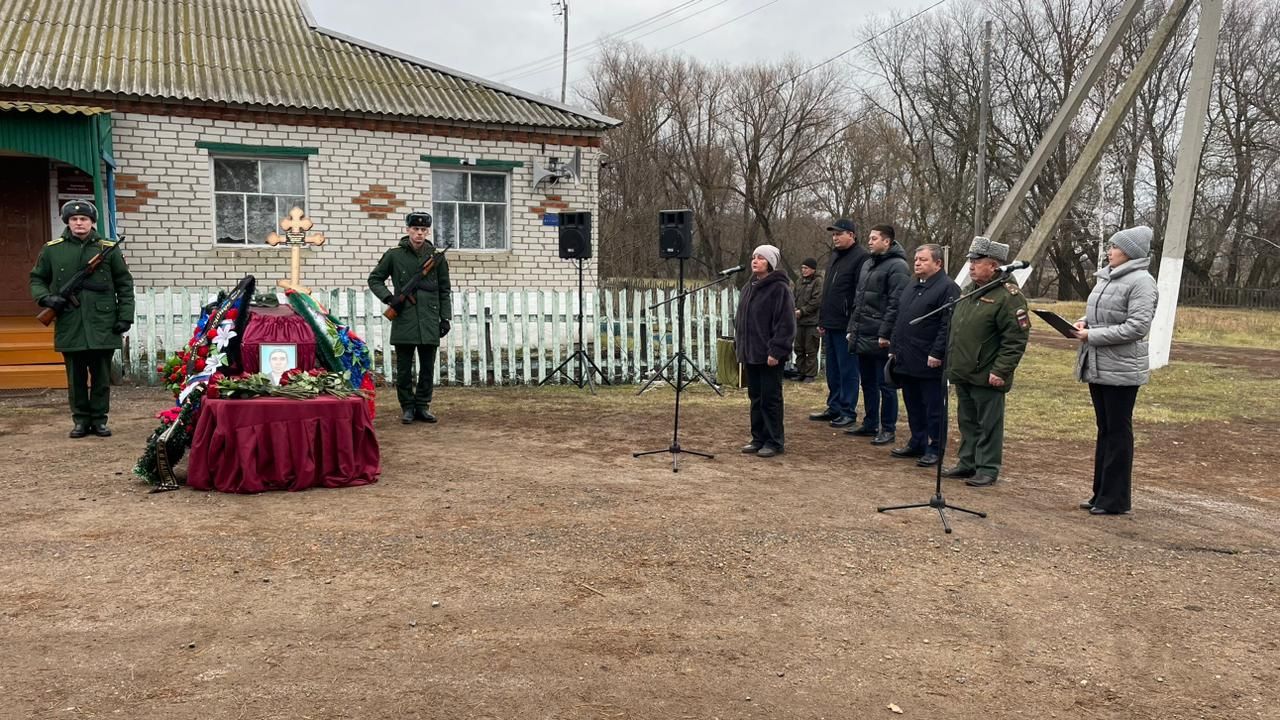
[31,200,133,438]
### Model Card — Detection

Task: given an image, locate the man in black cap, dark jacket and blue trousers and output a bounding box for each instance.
[809,218,867,428]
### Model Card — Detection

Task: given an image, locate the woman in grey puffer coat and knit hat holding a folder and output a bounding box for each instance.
[1075,225,1157,515]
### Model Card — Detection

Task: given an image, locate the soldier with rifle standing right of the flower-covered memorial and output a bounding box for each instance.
[369,213,453,425]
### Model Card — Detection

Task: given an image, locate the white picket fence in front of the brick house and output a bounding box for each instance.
[122,288,739,386]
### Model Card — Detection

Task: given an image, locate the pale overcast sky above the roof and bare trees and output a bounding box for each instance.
[307,0,911,101]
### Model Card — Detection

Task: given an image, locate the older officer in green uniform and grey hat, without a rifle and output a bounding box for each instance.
[942,237,1030,487]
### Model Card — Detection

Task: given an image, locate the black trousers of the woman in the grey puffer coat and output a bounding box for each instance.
[1089,383,1139,512]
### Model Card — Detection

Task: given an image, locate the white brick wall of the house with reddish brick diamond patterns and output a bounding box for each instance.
[113,113,599,290]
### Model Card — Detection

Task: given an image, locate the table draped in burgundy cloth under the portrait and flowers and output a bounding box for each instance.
[187,396,380,493]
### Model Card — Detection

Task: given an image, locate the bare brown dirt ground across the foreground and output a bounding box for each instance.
[0,345,1280,720]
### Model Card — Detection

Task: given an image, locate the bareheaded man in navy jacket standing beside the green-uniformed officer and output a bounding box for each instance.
[890,245,960,468]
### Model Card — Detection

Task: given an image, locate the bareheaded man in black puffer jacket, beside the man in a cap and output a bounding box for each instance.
[845,225,911,445]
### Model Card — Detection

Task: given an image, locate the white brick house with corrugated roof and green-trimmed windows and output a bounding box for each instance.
[0,0,617,307]
